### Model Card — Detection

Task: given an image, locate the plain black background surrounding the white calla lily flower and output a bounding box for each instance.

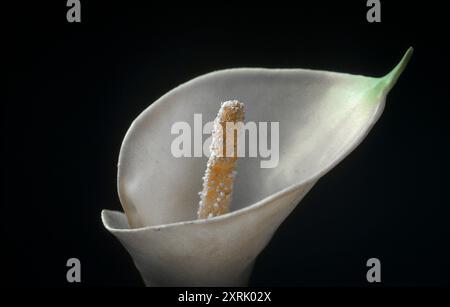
[1,0,450,286]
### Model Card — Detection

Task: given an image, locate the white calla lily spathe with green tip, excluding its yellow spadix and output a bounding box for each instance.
[102,48,412,286]
